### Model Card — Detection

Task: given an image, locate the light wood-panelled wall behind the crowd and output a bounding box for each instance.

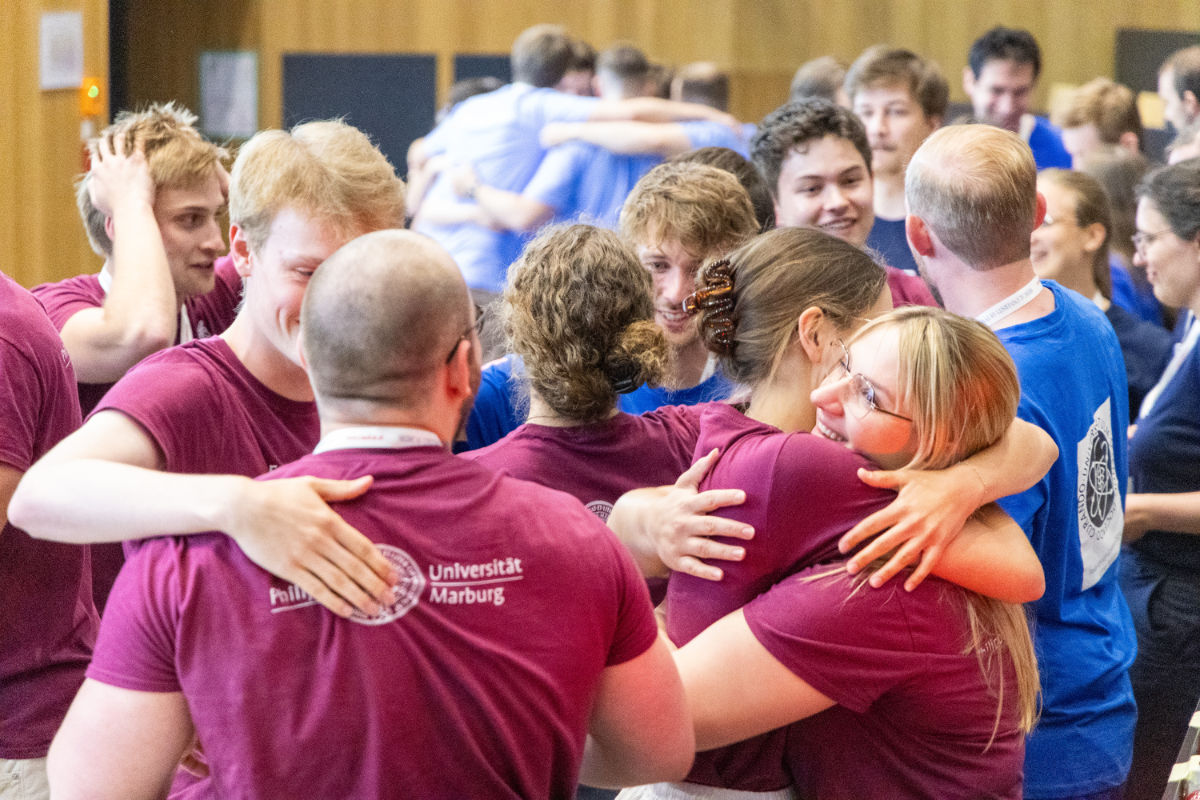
[14,0,1200,284]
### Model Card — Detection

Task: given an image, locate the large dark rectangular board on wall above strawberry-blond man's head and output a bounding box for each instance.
[283,53,437,181]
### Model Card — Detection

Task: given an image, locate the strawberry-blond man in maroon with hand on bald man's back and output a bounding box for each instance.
[10,121,404,652]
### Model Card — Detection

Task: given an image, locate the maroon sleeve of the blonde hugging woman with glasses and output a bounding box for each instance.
[744,564,941,714]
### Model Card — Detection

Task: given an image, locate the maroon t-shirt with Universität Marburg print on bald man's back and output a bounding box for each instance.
[88,447,656,800]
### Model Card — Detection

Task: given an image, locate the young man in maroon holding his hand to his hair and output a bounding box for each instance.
[34,103,241,416]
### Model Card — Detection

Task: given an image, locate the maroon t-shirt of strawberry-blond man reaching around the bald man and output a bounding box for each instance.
[95,336,320,476]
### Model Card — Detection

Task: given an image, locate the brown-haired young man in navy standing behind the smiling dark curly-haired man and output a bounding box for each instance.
[846,46,950,275]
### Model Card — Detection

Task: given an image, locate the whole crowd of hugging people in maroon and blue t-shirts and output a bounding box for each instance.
[0,18,1200,800]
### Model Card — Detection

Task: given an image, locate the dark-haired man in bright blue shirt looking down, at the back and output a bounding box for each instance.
[962,26,1070,169]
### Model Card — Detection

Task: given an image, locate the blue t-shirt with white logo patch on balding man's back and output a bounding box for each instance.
[996,281,1136,798]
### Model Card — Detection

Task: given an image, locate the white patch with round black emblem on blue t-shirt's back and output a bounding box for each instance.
[1076,398,1124,590]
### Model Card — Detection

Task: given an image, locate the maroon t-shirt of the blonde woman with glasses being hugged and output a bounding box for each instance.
[745,567,1025,800]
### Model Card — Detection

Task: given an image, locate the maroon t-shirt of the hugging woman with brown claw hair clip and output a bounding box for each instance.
[667,403,895,792]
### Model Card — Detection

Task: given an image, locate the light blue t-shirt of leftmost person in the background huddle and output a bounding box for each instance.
[416,83,600,291]
